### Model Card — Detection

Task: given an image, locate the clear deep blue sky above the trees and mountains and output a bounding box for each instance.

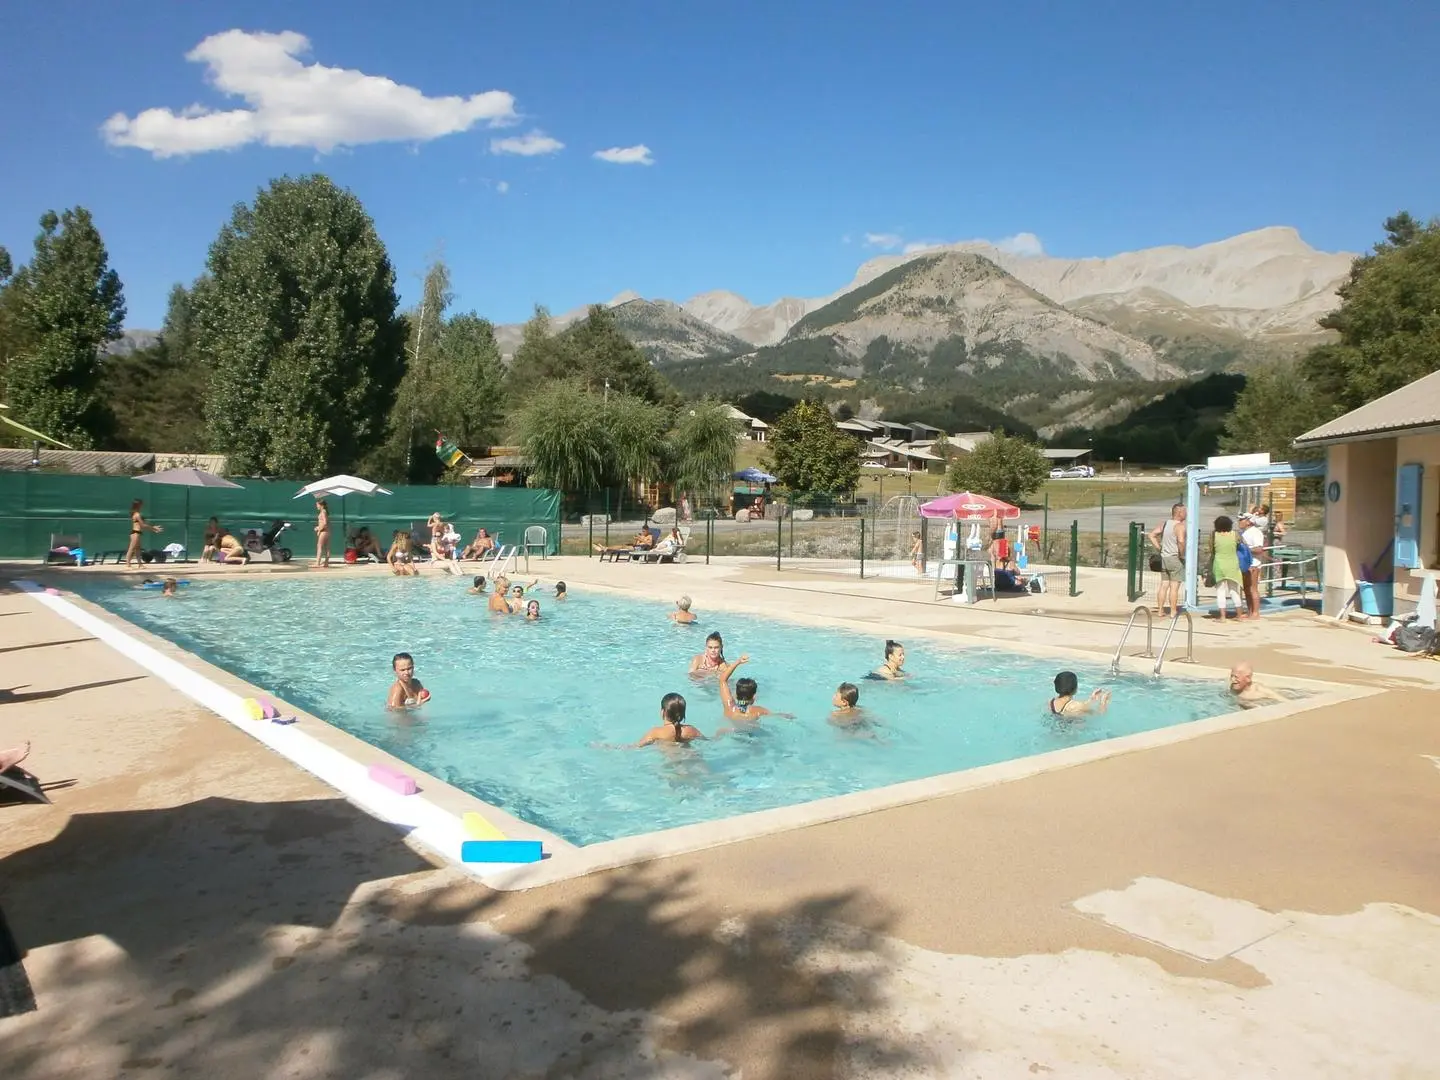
[0,0,1440,327]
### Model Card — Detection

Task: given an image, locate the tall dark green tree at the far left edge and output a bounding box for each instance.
[4,207,125,448]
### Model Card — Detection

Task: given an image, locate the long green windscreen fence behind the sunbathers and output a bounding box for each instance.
[0,472,560,559]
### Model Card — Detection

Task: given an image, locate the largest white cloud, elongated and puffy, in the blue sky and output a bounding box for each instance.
[101,30,516,157]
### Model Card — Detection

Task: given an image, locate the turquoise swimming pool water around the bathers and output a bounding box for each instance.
[85,578,1249,844]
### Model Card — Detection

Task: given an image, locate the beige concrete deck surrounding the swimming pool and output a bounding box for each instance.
[0,559,1440,1080]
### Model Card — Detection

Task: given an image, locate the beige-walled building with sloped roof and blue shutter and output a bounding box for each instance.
[1295,372,1440,615]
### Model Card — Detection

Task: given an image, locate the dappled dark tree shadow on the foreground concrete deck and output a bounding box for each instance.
[0,799,910,1080]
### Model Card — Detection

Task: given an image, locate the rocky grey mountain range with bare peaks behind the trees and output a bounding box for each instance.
[497,226,1354,389]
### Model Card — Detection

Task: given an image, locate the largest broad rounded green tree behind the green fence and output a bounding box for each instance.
[194,174,406,477]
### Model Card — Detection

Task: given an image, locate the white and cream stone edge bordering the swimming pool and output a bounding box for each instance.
[12,579,1382,890]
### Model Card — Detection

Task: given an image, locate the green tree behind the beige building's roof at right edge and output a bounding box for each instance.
[1300,213,1440,412]
